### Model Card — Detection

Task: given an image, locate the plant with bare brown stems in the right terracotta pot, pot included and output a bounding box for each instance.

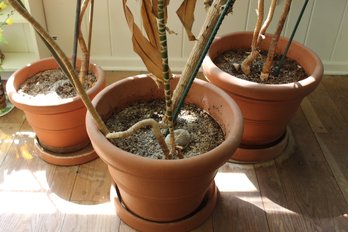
[202,0,323,162]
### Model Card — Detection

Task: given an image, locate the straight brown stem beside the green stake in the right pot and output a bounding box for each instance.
[260,0,292,81]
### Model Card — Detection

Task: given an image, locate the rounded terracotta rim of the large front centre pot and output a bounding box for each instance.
[86,74,243,179]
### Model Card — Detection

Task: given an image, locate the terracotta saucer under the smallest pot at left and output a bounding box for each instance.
[34,138,98,166]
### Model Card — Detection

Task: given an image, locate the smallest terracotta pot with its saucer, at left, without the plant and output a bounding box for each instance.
[6,58,105,165]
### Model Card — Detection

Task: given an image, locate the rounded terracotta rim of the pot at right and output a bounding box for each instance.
[202,32,324,98]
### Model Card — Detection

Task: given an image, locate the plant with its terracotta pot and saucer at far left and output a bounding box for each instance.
[6,0,105,165]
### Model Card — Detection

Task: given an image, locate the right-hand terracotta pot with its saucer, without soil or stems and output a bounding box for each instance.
[202,32,323,162]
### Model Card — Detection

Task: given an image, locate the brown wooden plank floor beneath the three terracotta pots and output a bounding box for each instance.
[0,72,348,232]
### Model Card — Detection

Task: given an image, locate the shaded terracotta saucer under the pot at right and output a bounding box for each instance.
[229,128,292,164]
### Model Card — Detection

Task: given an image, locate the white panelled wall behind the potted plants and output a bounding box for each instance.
[3,0,348,74]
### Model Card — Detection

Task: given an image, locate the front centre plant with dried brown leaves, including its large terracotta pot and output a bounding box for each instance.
[11,0,242,231]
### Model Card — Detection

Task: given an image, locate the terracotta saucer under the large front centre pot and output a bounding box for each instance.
[111,182,218,232]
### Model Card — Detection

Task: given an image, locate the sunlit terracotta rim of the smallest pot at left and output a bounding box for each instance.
[6,57,105,108]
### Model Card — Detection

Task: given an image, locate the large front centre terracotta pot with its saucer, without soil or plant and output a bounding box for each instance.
[86,75,243,231]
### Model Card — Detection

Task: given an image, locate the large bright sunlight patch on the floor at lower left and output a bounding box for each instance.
[0,167,115,215]
